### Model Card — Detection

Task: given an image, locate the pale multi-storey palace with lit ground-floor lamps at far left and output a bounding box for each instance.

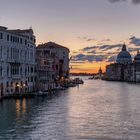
[0,26,36,96]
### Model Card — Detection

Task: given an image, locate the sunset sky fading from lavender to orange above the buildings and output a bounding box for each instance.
[0,0,140,73]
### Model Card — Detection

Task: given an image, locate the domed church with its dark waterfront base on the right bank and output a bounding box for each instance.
[103,44,140,82]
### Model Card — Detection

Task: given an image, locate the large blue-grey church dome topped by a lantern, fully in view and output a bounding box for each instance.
[117,44,132,64]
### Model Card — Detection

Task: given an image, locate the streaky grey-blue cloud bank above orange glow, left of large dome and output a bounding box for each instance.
[73,44,122,62]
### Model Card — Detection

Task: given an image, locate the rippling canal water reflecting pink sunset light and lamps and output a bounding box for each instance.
[0,78,140,140]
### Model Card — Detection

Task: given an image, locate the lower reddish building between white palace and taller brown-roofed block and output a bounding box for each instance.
[36,47,59,91]
